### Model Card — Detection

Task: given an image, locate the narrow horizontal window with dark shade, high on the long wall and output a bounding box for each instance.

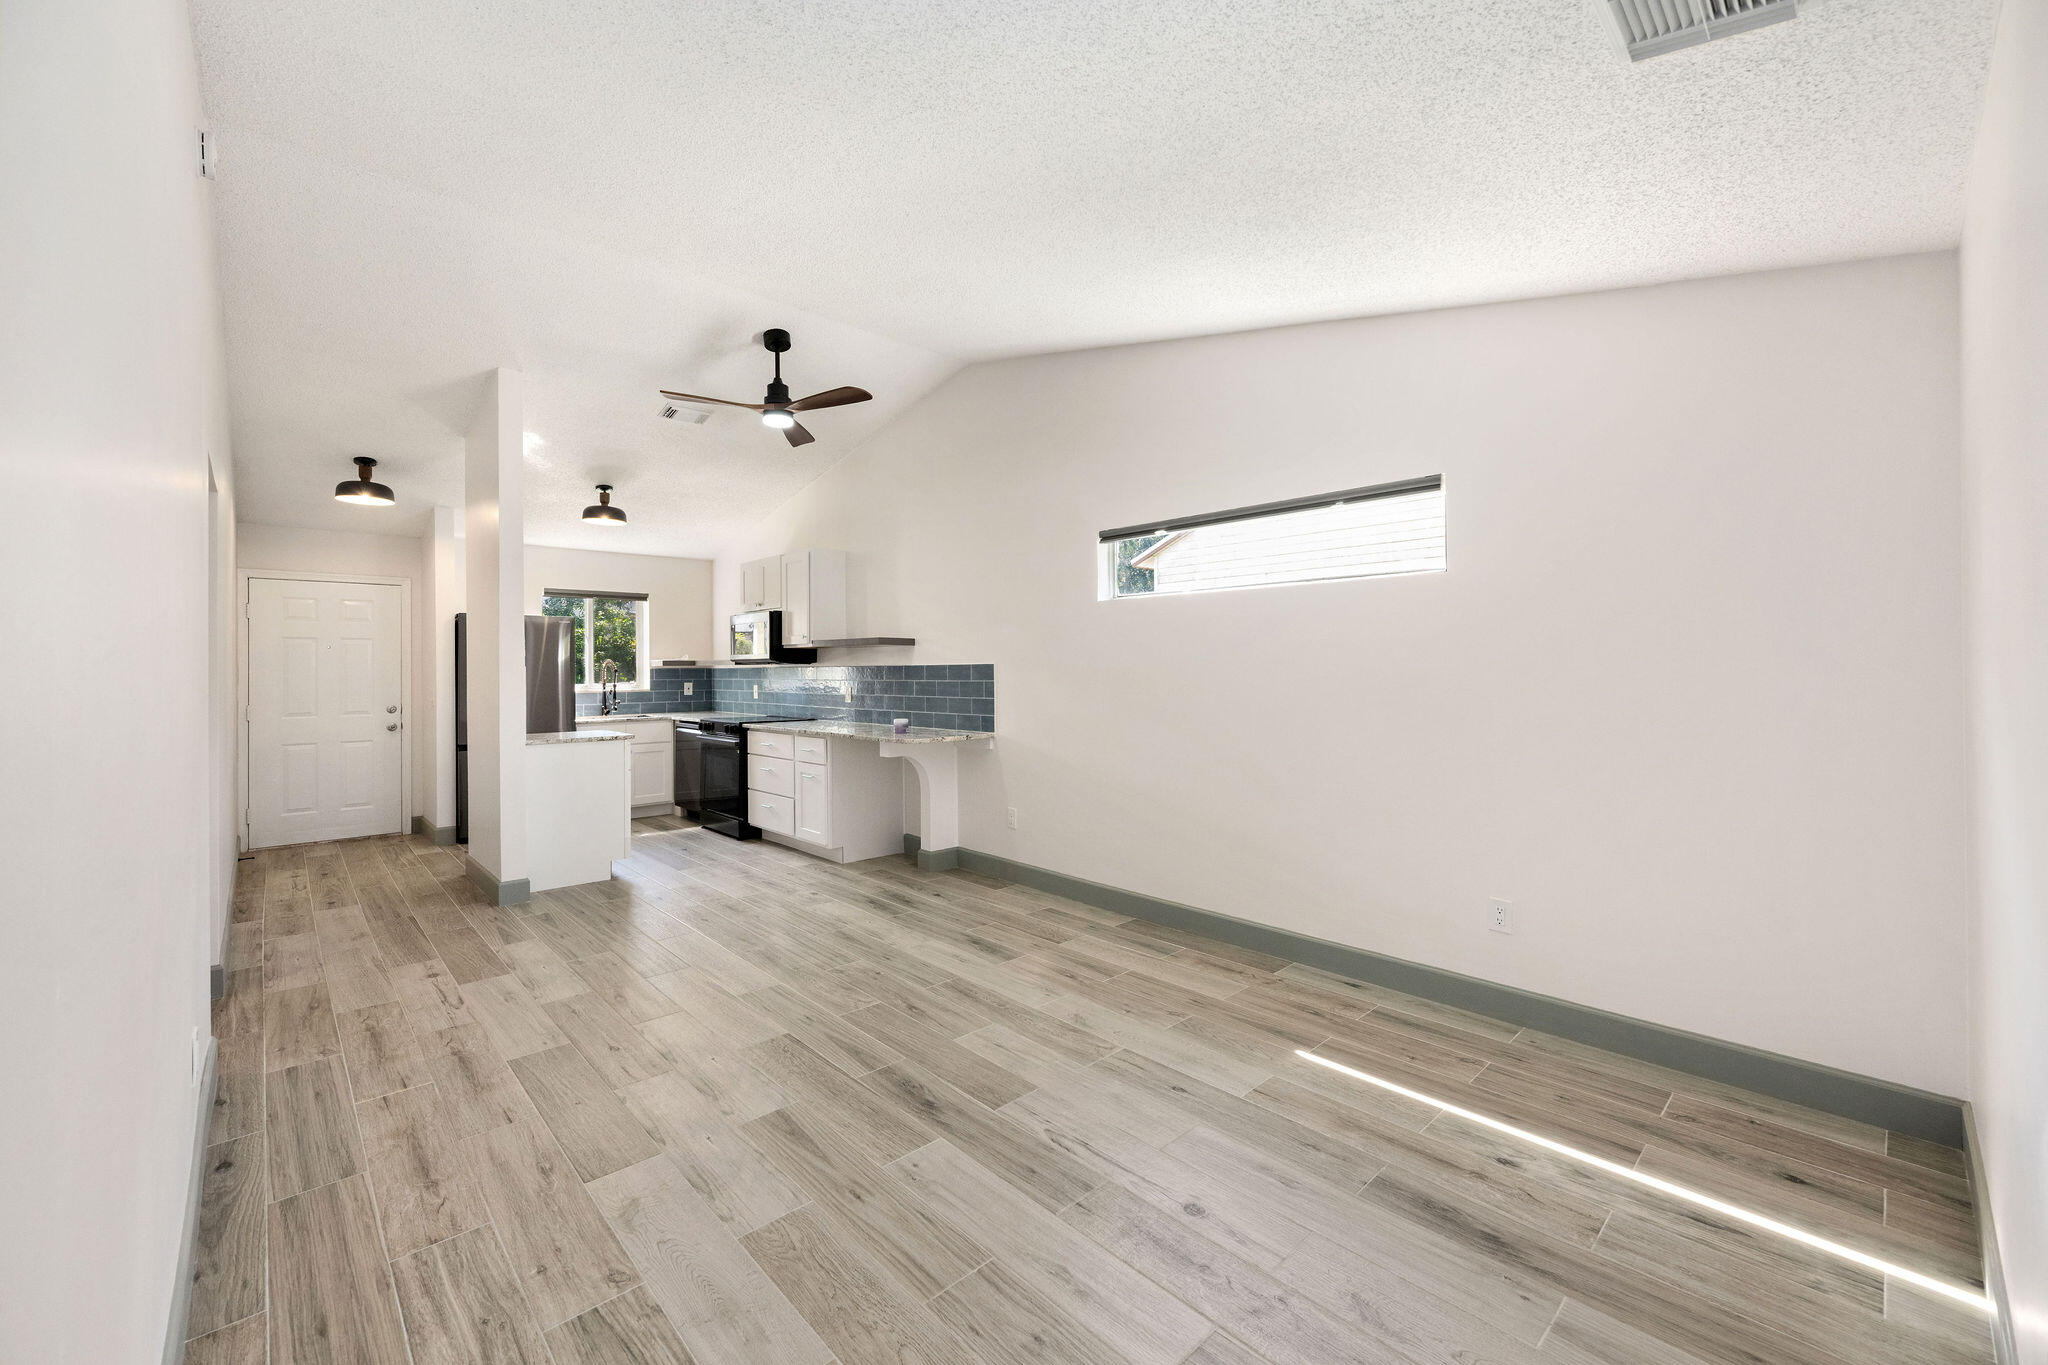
[1100,475,1444,600]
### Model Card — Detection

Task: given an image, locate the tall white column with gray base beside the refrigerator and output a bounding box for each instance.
[463,370,530,905]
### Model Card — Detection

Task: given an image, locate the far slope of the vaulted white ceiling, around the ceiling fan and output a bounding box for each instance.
[215,131,954,555]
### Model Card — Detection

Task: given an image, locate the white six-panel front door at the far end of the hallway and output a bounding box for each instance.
[250,579,406,849]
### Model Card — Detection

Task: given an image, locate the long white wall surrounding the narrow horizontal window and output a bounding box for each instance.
[713,254,1966,1093]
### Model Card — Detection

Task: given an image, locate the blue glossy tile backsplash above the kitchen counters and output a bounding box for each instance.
[575,663,995,731]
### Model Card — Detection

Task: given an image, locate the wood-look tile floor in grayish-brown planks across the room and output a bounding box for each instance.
[186,819,1991,1365]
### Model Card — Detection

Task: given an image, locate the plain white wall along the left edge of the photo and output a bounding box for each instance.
[0,0,231,1363]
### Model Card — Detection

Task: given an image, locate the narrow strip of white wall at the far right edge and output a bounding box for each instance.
[1962,0,2048,1365]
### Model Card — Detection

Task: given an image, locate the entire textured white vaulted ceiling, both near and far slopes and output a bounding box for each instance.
[195,0,1997,553]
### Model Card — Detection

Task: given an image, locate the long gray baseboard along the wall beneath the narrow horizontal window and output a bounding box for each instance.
[950,847,1964,1148]
